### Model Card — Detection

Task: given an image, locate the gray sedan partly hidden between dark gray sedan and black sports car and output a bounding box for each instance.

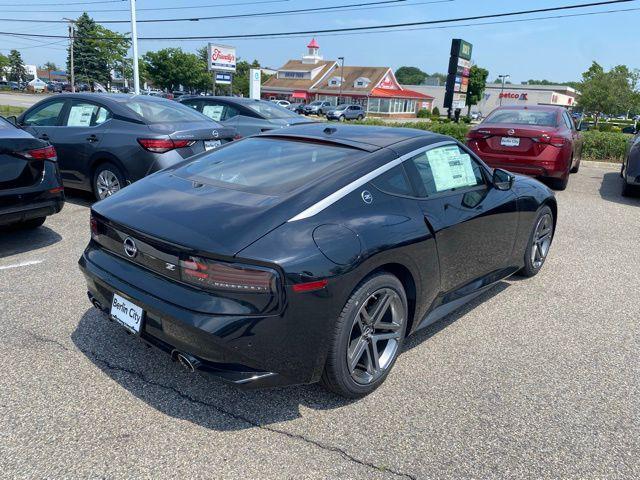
[179,96,310,137]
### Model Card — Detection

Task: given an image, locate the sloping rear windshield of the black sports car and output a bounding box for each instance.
[175,137,365,195]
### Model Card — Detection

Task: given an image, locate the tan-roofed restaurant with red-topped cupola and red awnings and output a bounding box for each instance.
[261,39,433,118]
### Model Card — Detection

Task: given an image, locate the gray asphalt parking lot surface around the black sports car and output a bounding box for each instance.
[0,163,640,479]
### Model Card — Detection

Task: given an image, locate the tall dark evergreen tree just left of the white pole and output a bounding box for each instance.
[67,13,130,85]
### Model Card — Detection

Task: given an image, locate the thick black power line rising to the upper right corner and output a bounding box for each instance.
[0,0,636,41]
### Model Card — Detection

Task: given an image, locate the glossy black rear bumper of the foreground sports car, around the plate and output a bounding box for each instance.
[79,246,328,388]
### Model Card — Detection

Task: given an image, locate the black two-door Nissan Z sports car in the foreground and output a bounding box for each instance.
[80,124,557,397]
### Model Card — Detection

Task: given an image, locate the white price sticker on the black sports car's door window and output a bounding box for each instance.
[427,145,477,192]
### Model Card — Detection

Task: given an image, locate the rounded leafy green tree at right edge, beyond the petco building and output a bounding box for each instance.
[579,61,639,125]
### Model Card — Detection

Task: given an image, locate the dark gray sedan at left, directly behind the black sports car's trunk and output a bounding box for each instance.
[12,93,235,200]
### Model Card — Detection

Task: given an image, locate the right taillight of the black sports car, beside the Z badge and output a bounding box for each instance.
[180,257,276,293]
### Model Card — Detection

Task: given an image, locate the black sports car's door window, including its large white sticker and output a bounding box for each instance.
[408,145,485,196]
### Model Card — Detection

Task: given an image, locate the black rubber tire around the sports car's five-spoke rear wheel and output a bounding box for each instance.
[321,272,408,399]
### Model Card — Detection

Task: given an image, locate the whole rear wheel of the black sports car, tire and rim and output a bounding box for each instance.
[322,273,408,398]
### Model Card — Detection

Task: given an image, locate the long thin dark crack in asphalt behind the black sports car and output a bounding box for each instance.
[25,330,417,480]
